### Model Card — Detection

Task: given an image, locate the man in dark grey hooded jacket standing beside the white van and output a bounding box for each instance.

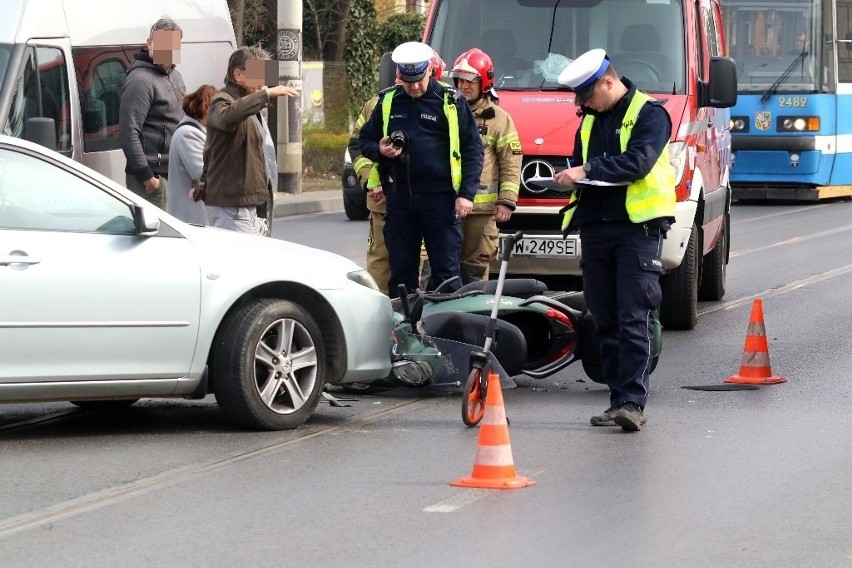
[119,16,186,209]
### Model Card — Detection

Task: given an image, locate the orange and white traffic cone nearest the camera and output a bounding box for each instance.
[450,373,535,489]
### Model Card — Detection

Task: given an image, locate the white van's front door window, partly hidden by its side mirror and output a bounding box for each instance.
[7,46,71,155]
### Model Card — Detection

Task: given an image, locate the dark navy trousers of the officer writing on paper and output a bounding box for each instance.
[580,222,663,408]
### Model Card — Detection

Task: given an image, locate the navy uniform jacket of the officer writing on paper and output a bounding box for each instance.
[571,78,672,227]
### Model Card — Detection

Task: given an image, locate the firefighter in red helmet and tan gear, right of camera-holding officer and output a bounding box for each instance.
[450,48,523,284]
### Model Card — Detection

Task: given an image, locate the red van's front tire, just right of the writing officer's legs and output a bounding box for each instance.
[660,223,698,330]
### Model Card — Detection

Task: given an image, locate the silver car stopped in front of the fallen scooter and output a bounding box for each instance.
[0,136,393,430]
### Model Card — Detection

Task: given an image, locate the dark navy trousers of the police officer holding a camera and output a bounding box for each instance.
[385,191,462,298]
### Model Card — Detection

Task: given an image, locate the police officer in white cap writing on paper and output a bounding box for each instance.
[554,49,675,432]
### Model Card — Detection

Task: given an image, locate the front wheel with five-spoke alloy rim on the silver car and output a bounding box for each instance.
[213,298,325,430]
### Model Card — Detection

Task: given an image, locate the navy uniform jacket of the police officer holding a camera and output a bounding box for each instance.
[358,79,483,200]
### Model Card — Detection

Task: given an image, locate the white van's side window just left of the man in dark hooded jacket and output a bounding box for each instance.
[72,45,142,152]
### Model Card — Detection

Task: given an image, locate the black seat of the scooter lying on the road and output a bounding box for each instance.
[423,312,527,376]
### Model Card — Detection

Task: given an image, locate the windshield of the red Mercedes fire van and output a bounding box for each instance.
[429,0,685,94]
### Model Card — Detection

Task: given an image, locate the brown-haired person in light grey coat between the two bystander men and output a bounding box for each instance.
[166,116,207,225]
